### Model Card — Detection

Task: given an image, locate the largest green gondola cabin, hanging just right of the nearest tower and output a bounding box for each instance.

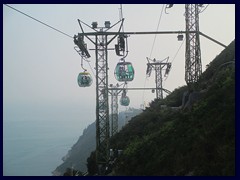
[114,62,134,81]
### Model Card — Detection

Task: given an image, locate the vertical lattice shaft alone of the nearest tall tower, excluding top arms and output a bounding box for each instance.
[95,32,110,164]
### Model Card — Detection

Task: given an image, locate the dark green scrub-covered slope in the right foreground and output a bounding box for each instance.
[88,41,235,176]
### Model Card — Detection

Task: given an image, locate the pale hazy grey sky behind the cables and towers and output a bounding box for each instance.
[3,4,235,126]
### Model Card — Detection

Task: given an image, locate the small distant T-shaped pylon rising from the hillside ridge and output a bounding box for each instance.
[146,57,171,99]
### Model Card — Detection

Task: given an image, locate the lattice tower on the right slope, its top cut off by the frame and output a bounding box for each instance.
[185,4,202,88]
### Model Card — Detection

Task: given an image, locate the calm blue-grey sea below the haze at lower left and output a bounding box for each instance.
[3,117,88,176]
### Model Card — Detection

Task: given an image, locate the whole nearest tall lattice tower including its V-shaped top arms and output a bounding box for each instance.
[78,20,123,171]
